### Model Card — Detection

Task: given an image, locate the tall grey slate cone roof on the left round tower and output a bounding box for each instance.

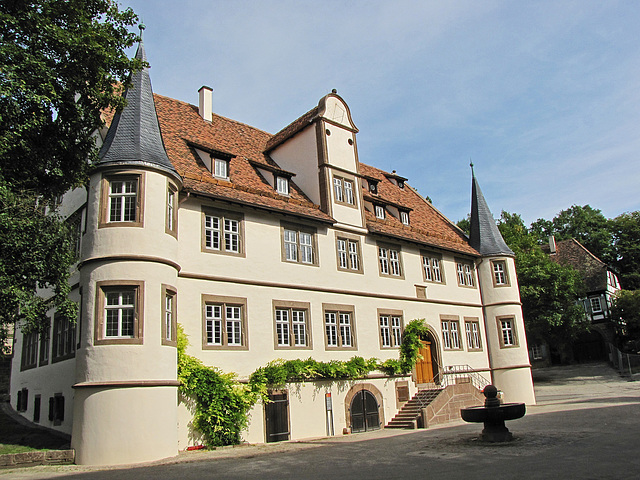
[96,28,181,181]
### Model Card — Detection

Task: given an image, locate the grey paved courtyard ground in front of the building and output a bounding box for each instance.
[5,364,640,480]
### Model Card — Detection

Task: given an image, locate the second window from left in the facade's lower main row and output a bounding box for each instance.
[274,302,311,348]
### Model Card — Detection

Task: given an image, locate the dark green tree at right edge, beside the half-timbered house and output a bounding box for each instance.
[609,211,640,290]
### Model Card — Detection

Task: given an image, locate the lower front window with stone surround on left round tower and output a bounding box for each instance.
[95,280,144,345]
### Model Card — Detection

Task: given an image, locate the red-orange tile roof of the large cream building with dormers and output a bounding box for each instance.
[107,94,478,256]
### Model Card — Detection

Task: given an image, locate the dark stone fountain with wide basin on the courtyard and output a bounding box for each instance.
[460,385,526,442]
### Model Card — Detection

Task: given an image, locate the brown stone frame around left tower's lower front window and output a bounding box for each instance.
[94,280,144,345]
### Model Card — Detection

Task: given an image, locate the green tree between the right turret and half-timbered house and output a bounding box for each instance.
[498,211,589,362]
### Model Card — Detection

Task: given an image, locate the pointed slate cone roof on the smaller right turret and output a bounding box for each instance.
[469,170,514,256]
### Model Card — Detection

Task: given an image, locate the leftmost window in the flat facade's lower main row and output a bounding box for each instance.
[203,295,247,349]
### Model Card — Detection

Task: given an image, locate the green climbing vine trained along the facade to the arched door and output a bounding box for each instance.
[178,319,429,447]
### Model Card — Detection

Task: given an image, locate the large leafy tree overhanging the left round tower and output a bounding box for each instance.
[0,0,142,340]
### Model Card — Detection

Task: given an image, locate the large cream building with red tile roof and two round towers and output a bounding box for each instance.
[11,35,535,464]
